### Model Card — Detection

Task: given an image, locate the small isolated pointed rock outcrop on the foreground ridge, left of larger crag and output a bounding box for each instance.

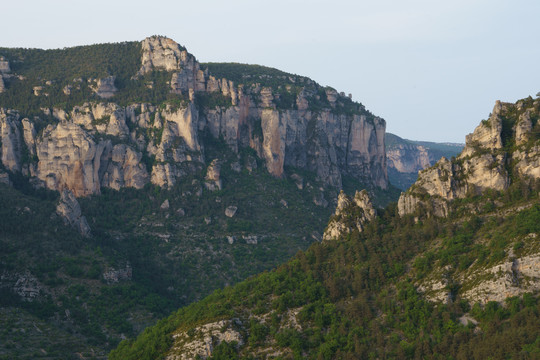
[323,190,376,241]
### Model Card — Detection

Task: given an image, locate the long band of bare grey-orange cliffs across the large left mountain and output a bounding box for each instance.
[0,37,388,197]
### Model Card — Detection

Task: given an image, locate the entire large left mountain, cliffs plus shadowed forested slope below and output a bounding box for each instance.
[0,36,399,359]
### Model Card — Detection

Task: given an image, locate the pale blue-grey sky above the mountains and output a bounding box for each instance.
[0,0,540,143]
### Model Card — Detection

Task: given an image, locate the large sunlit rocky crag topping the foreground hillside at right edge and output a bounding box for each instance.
[398,98,540,217]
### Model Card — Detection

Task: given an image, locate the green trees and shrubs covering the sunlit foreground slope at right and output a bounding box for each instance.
[110,176,540,359]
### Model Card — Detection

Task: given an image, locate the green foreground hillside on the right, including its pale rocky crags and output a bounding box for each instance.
[110,98,540,360]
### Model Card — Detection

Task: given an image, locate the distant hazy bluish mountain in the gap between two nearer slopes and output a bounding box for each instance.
[385,133,463,190]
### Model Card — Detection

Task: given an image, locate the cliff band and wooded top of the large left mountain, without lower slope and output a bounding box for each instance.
[0,36,388,196]
